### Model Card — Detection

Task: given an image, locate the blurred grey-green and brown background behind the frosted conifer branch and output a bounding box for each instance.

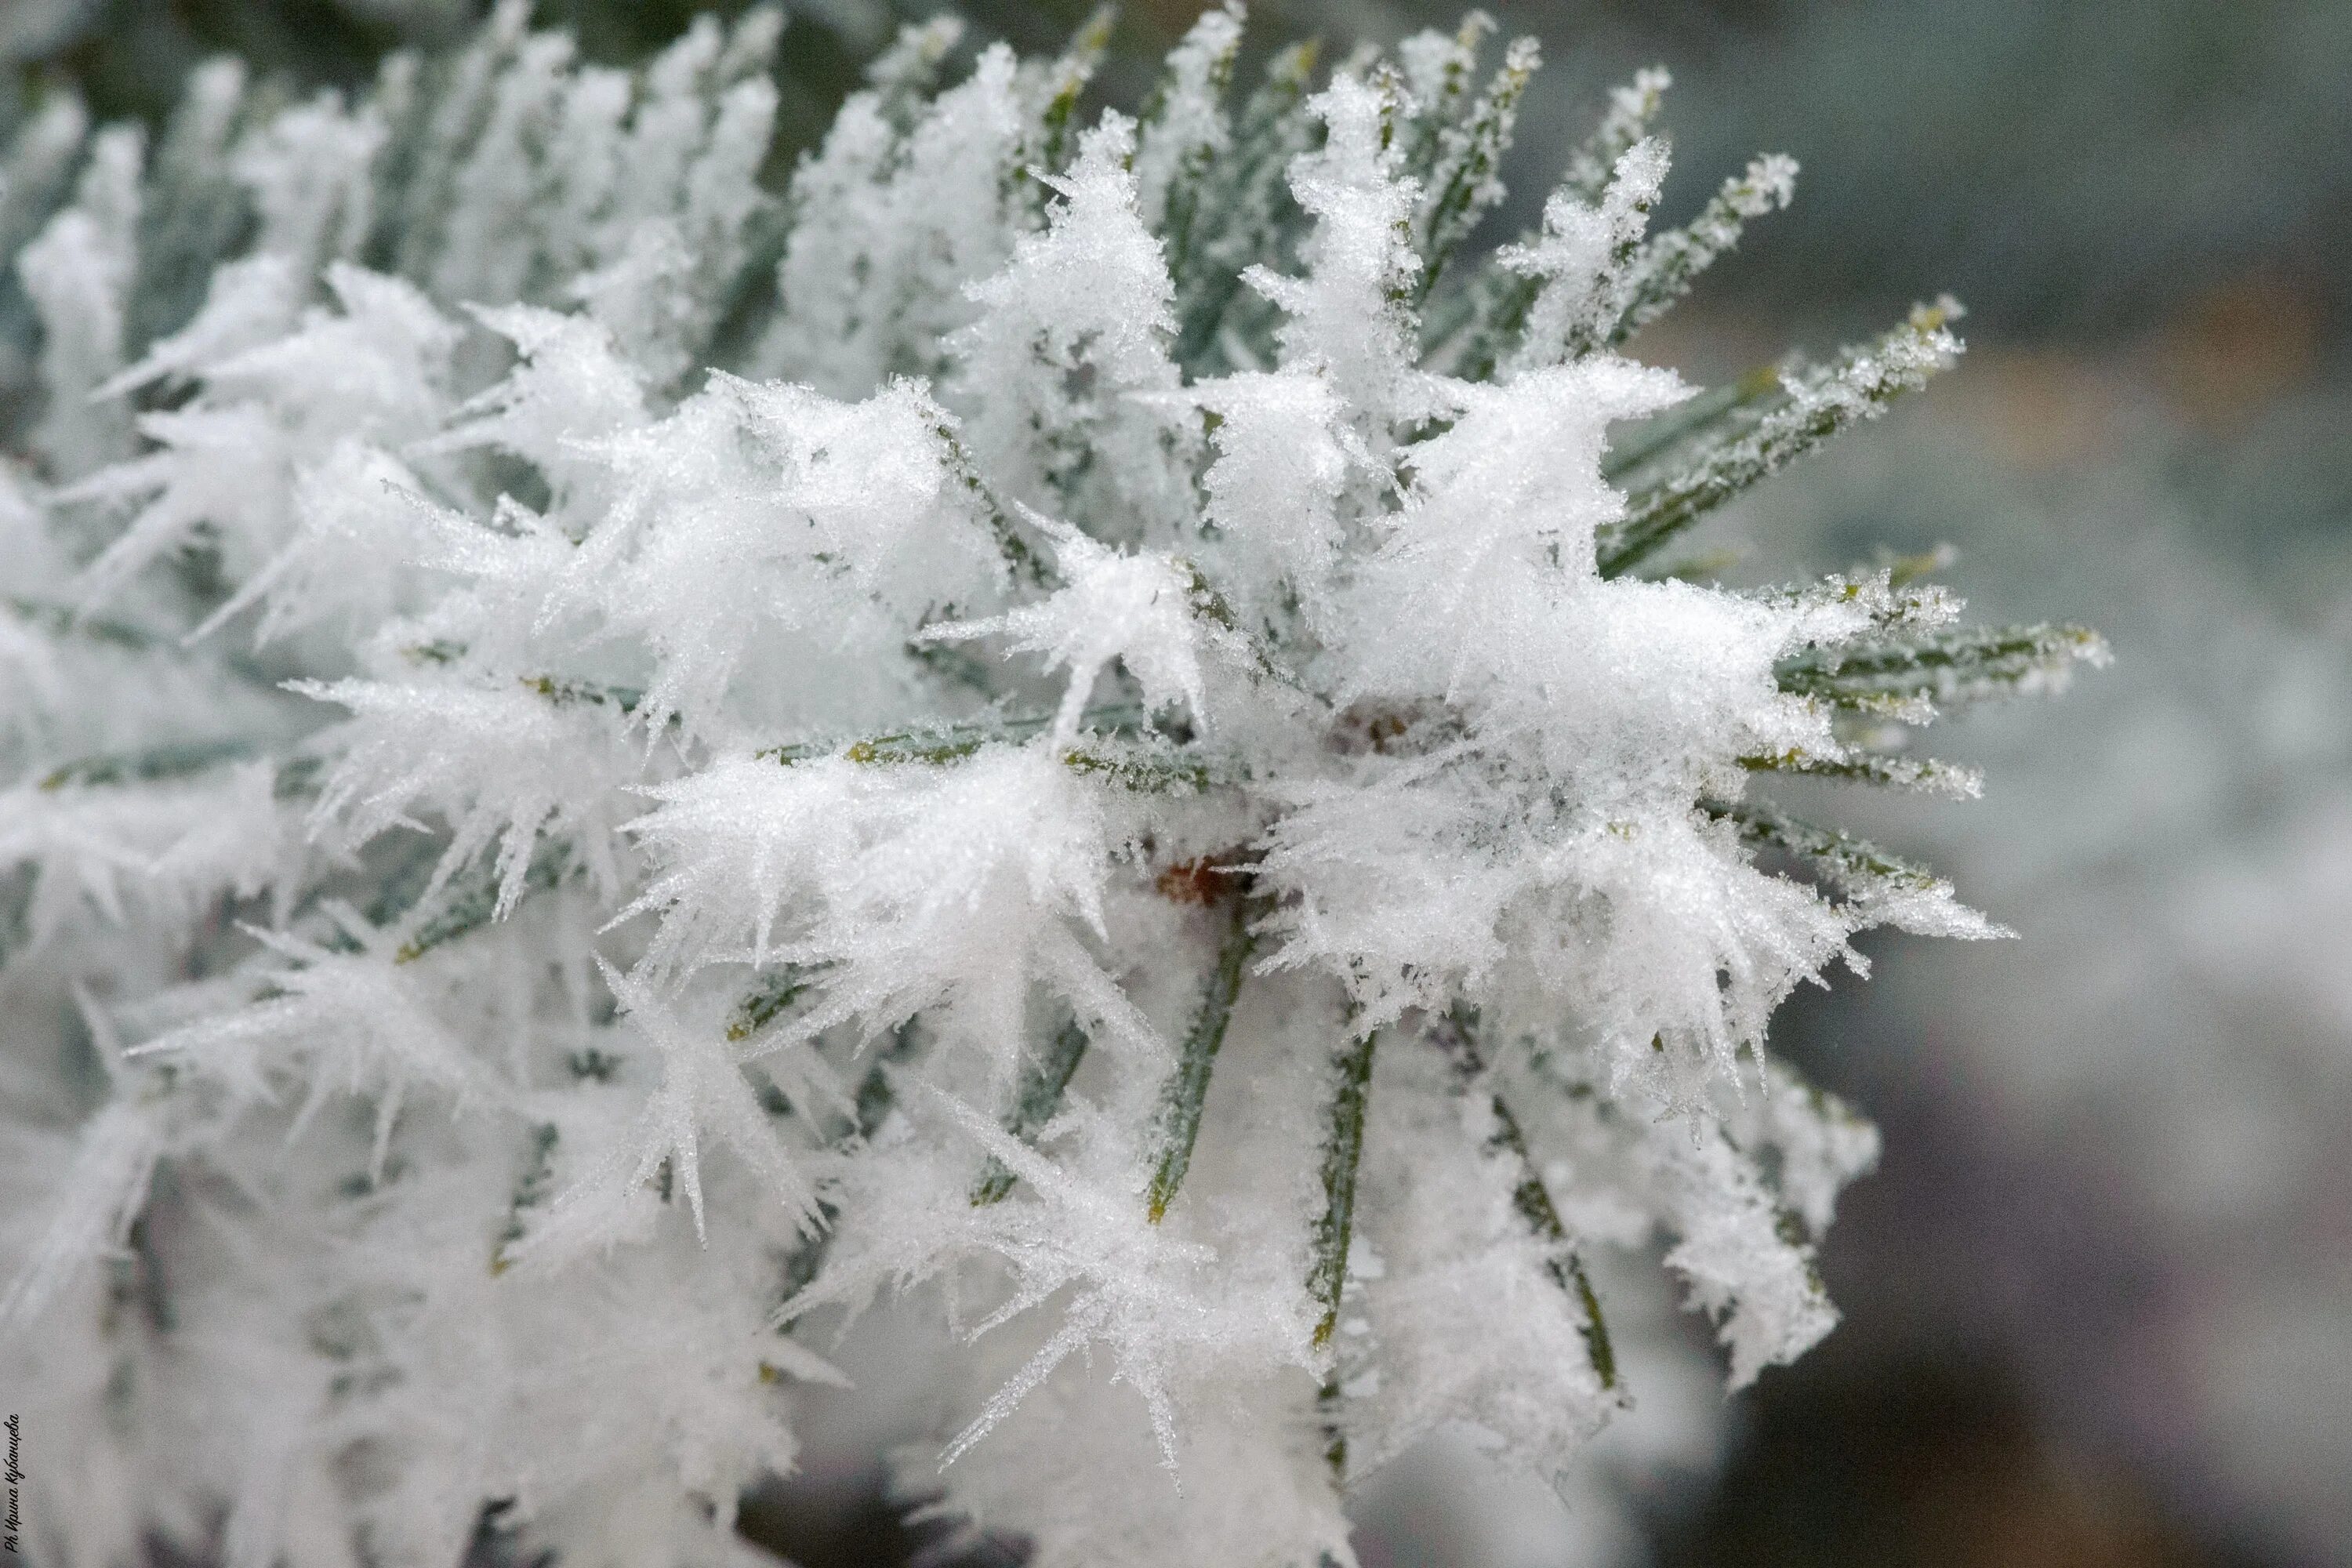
[0,0,2352,1568]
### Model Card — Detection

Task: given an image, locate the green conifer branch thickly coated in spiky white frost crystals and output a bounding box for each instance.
[0,5,2098,1568]
